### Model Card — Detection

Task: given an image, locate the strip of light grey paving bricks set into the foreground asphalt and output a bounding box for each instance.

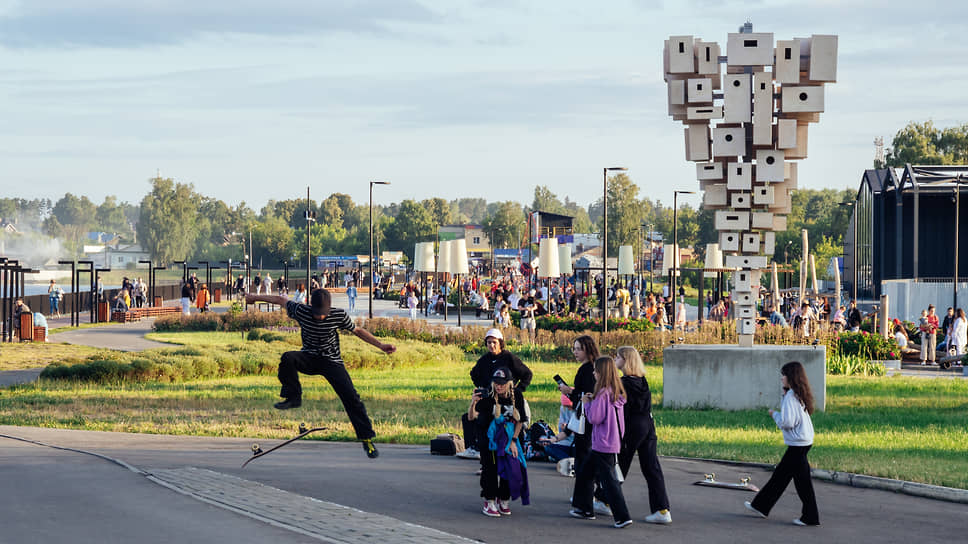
[148,467,476,544]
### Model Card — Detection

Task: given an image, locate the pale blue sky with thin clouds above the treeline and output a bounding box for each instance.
[0,0,968,211]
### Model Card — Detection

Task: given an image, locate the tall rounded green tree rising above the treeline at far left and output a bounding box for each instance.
[138,177,198,263]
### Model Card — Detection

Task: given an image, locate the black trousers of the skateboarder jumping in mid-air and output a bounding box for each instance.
[279,351,376,440]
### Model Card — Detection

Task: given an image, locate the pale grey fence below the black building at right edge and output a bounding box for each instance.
[881,278,968,323]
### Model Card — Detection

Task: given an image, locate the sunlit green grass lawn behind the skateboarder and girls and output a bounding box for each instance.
[0,333,968,488]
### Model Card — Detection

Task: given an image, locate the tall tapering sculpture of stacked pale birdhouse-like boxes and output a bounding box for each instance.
[663,27,837,345]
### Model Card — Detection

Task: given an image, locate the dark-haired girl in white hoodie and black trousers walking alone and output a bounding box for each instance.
[745,362,820,525]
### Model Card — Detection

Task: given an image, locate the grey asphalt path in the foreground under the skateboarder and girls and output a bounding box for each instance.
[0,427,968,543]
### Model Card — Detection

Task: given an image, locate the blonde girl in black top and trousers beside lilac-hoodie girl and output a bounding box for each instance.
[615,346,672,523]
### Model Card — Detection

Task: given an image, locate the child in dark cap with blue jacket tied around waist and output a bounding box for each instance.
[467,368,530,517]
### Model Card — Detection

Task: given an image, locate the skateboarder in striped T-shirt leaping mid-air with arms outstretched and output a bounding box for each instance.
[245,289,397,459]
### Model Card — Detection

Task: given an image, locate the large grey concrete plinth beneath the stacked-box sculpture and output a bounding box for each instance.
[662,344,827,412]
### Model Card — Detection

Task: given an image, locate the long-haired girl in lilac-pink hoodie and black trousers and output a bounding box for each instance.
[569,357,632,529]
